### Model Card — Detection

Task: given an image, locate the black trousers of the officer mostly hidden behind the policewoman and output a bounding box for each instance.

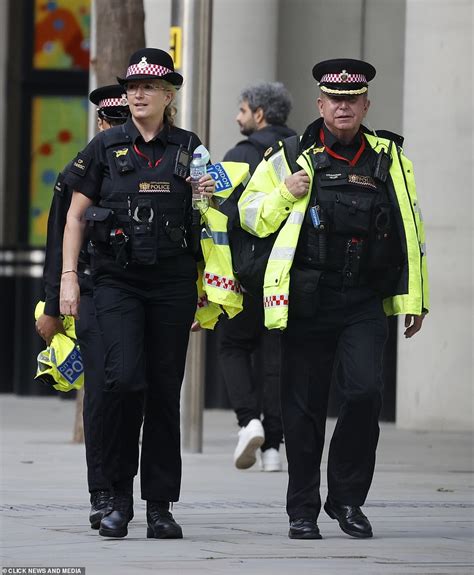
[76,274,108,492]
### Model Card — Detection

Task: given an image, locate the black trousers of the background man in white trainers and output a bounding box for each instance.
[217,293,283,450]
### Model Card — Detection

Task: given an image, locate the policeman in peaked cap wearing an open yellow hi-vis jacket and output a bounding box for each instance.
[239,59,429,539]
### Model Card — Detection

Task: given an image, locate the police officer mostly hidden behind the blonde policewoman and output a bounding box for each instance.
[36,84,129,529]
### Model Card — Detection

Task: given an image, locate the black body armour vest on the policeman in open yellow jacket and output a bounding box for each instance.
[295,137,401,285]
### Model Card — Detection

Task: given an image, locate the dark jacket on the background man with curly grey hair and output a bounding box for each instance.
[224,124,296,174]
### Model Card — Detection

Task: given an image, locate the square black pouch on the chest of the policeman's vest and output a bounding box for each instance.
[332,193,373,236]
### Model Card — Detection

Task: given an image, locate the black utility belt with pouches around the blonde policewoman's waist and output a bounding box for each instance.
[85,198,191,268]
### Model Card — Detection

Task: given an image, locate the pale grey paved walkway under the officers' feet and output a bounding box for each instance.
[0,395,474,575]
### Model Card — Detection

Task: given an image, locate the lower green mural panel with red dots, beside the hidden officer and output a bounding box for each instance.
[29,96,88,246]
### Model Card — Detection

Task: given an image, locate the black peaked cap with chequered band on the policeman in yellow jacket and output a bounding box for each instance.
[313,58,375,96]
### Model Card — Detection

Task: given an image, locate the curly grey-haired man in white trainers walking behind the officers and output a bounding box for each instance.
[217,82,295,471]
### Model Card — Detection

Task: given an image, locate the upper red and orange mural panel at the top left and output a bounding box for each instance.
[33,0,91,70]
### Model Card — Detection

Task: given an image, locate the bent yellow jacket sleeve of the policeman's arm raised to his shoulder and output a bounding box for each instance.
[238,150,297,237]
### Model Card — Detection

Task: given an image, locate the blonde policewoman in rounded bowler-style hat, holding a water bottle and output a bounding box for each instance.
[61,48,215,538]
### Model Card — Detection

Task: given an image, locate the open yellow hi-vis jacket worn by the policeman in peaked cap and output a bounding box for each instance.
[239,130,429,329]
